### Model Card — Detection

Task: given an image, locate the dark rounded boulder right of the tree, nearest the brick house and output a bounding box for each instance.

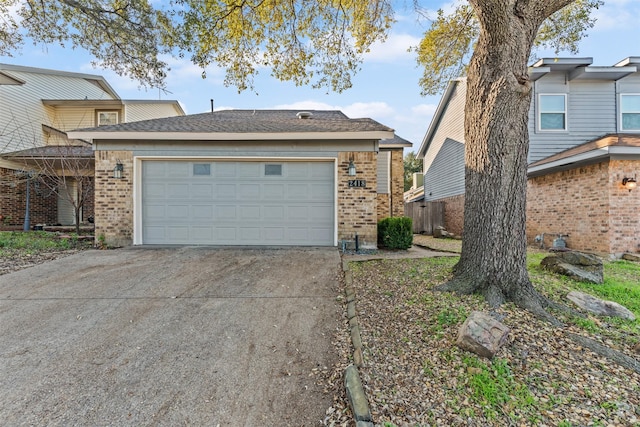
[540,251,604,284]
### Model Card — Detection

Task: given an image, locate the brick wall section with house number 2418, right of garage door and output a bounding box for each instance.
[337,152,378,247]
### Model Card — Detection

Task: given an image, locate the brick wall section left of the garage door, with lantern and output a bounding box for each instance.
[95,151,133,246]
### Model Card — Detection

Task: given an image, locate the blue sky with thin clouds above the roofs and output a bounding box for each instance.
[0,0,640,150]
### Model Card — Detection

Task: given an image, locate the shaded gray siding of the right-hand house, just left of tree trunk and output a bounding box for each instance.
[424,138,464,201]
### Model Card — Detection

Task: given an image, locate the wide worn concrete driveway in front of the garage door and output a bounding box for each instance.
[0,247,341,426]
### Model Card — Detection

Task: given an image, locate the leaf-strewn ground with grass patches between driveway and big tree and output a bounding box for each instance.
[325,241,640,427]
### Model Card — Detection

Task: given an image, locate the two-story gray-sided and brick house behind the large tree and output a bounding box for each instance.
[405,57,640,255]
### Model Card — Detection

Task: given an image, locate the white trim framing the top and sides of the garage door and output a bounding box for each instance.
[133,156,338,246]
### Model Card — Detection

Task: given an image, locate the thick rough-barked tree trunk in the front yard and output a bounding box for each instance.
[444,0,572,315]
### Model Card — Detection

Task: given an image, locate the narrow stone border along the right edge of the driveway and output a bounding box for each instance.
[342,260,373,427]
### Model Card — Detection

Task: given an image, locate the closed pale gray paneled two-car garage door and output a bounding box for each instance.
[142,160,335,246]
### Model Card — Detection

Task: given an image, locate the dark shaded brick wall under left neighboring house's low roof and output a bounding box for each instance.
[0,168,58,226]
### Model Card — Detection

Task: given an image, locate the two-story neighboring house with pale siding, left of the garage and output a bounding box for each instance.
[0,64,184,226]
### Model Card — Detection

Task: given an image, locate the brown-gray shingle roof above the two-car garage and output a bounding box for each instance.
[76,110,393,133]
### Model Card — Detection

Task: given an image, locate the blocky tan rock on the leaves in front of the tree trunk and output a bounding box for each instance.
[456,311,509,359]
